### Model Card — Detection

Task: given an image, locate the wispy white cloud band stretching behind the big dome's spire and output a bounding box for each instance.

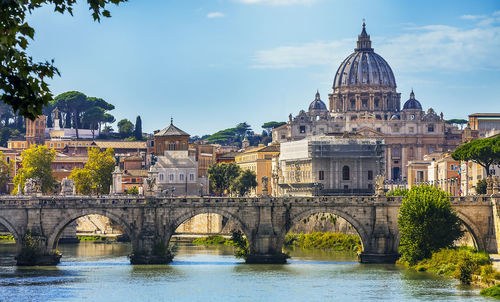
[252,13,500,72]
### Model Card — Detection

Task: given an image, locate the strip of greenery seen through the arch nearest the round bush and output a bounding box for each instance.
[284,232,362,251]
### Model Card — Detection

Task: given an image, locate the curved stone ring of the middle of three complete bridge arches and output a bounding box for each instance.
[165,208,253,246]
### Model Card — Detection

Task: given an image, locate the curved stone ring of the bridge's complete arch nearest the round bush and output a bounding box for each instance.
[279,207,370,251]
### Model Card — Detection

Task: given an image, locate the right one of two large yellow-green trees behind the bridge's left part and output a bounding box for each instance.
[70,148,115,195]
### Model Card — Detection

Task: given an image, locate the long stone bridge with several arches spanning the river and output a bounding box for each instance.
[0,195,500,264]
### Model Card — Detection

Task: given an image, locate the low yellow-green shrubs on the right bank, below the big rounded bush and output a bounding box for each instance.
[406,247,500,284]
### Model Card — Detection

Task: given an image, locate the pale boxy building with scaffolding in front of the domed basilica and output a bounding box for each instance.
[273,134,385,196]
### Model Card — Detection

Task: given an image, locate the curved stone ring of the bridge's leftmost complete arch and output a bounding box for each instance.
[47,208,137,250]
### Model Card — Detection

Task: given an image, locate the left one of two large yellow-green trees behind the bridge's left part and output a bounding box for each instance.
[12,145,56,194]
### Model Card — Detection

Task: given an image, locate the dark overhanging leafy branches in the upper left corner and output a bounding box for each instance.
[0,0,125,120]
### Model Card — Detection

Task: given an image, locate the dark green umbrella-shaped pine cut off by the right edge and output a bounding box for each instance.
[451,136,500,176]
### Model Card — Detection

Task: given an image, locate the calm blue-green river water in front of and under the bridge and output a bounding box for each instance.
[0,242,493,302]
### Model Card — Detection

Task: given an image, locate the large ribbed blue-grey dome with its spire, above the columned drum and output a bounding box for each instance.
[333,23,396,89]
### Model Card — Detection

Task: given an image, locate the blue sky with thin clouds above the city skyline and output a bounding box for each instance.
[25,0,500,136]
